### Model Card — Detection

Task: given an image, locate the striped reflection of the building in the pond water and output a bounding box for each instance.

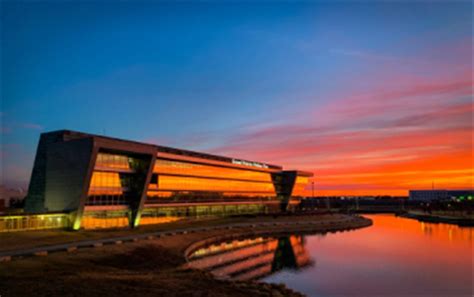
[189,235,313,280]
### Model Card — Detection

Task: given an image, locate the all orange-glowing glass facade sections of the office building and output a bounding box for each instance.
[82,152,309,229]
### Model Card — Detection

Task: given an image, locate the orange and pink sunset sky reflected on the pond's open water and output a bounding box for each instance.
[262,215,474,297]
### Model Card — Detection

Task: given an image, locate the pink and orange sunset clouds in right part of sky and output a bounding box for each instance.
[211,37,474,194]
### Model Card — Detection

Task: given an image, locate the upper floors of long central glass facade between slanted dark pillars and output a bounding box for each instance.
[147,159,276,203]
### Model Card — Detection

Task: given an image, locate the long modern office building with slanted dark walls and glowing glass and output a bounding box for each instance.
[19,130,312,230]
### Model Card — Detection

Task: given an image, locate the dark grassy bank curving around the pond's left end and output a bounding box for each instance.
[0,214,372,297]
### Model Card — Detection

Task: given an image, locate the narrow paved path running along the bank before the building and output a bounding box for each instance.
[0,217,360,262]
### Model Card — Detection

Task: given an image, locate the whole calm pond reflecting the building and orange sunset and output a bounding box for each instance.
[190,215,474,297]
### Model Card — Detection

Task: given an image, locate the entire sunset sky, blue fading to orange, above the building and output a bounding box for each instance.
[0,1,474,195]
